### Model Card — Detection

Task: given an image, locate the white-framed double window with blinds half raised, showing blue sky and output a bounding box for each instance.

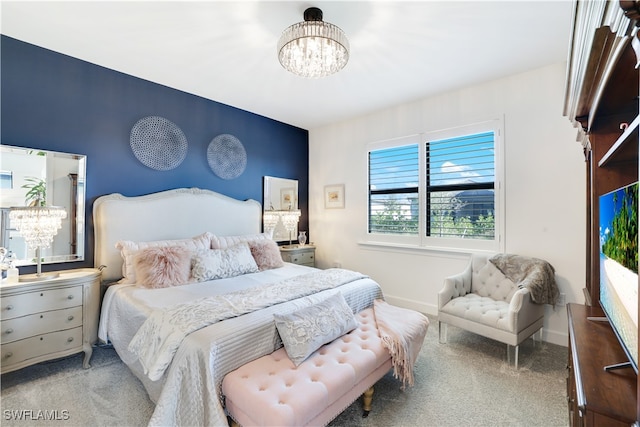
[368,121,503,250]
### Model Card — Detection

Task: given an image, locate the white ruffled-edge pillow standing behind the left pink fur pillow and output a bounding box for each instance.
[116,232,213,283]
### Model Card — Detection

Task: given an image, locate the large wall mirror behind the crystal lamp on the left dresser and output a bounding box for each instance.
[0,145,86,266]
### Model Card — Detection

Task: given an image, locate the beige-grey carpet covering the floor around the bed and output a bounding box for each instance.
[0,318,568,427]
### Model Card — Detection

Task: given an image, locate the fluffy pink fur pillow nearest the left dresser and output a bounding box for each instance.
[135,246,192,288]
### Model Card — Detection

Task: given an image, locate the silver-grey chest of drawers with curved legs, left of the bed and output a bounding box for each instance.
[0,268,101,373]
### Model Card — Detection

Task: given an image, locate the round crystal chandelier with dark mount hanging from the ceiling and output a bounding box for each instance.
[278,7,349,78]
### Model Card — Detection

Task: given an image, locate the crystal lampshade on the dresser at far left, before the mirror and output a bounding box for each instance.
[9,206,67,248]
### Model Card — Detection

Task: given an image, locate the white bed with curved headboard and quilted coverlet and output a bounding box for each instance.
[93,189,382,425]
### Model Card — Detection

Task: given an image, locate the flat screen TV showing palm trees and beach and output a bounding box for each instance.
[599,182,638,374]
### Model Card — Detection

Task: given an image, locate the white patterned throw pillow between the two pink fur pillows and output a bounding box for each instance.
[191,242,259,282]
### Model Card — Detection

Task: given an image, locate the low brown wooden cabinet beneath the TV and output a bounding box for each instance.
[567,304,637,427]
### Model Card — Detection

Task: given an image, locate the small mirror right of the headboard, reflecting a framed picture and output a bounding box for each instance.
[262,176,298,242]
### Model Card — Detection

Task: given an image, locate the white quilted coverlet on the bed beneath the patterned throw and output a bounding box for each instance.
[100,263,382,426]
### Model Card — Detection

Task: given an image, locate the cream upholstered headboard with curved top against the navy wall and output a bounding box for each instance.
[93,188,262,280]
